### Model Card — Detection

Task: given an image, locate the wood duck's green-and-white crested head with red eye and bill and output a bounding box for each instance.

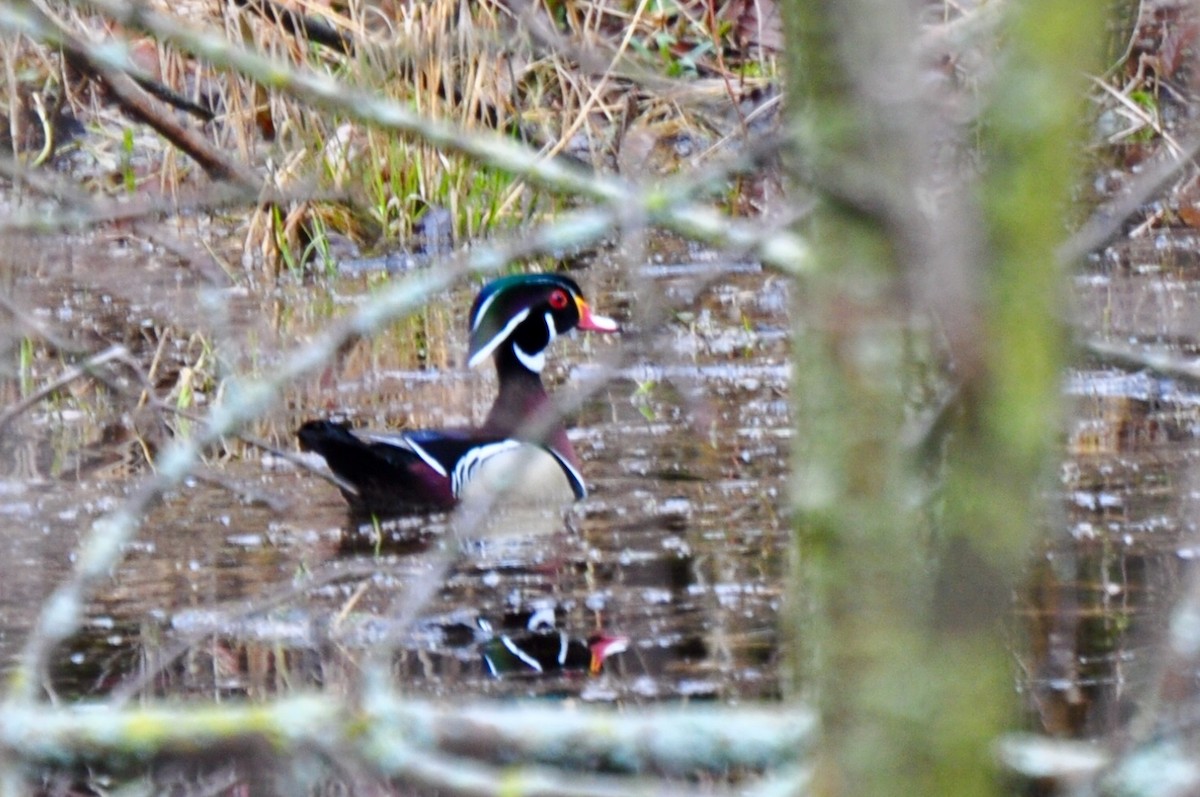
[467,274,619,373]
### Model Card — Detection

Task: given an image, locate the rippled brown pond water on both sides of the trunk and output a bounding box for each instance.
[0,229,1200,736]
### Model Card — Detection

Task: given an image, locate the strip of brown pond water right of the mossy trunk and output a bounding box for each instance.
[1019,246,1200,737]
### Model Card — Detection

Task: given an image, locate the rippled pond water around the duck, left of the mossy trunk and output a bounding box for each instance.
[0,244,790,701]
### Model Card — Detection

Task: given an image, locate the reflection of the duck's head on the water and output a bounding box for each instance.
[479,612,629,678]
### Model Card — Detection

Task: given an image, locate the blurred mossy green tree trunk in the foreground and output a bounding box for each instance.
[784,0,1104,797]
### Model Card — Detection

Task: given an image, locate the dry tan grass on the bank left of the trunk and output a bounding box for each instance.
[0,0,775,275]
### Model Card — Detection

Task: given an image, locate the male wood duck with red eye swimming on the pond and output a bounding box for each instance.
[299,274,618,515]
